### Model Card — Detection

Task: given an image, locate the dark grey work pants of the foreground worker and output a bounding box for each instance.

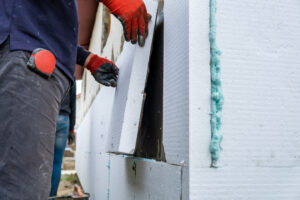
[0,41,70,200]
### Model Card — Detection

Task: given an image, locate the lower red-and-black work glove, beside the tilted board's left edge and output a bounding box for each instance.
[86,54,119,87]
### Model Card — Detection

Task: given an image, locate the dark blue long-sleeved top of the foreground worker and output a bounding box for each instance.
[0,0,89,79]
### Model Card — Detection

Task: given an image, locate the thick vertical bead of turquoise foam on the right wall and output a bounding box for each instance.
[209,0,224,167]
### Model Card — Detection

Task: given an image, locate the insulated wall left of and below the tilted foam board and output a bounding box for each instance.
[76,0,183,200]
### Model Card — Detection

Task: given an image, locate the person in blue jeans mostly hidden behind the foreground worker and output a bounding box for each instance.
[50,77,76,197]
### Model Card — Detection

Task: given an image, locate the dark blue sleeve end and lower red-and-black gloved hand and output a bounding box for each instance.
[77,46,119,87]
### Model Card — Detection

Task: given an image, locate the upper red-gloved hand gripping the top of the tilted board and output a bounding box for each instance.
[101,0,151,46]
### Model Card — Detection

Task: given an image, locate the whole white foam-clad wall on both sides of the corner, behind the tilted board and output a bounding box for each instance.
[76,0,300,200]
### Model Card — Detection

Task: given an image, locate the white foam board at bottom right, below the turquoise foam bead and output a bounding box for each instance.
[190,167,300,200]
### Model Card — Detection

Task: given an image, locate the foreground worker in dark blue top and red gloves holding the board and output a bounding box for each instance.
[0,0,149,200]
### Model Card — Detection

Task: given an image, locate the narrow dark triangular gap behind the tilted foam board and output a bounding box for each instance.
[134,1,166,161]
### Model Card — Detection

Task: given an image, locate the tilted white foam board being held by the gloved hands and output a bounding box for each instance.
[107,0,158,154]
